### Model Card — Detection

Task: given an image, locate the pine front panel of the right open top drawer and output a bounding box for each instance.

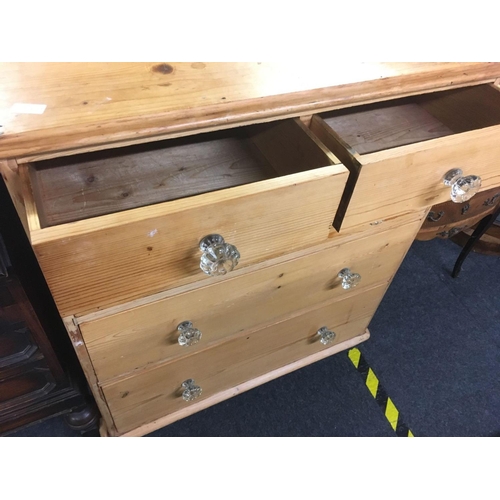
[314,122,500,232]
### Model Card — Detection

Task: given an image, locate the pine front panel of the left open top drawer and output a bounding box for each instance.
[32,165,347,316]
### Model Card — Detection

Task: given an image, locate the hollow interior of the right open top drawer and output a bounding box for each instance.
[311,85,500,155]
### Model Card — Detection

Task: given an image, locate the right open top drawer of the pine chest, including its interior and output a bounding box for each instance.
[310,85,500,230]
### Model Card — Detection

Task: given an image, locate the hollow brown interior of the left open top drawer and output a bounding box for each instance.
[29,120,340,227]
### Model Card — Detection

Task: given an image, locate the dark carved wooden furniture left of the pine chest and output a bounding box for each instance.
[0,181,99,435]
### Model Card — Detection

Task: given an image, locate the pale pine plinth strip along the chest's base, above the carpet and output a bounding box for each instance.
[115,329,370,437]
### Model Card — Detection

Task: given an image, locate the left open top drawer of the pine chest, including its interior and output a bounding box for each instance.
[3,120,348,316]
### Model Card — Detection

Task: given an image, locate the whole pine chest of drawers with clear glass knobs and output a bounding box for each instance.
[0,63,500,436]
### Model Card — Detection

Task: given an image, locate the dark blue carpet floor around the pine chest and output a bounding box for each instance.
[7,236,500,437]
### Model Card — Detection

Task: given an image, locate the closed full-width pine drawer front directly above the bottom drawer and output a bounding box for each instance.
[80,216,421,381]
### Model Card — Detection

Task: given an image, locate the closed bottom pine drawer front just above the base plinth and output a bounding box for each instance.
[102,285,387,434]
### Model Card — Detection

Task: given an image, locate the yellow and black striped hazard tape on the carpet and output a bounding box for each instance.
[348,347,414,437]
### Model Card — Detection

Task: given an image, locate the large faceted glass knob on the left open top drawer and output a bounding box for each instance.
[200,234,240,276]
